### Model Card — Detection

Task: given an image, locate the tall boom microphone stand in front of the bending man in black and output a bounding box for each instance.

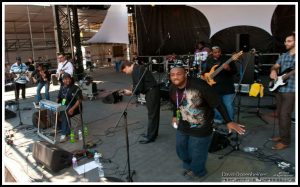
[114,63,151,182]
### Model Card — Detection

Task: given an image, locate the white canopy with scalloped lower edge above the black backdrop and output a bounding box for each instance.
[191,5,277,38]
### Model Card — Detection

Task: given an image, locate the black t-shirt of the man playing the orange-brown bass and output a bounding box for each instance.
[204,55,237,95]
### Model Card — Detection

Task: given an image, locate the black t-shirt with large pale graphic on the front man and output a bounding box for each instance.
[170,78,220,137]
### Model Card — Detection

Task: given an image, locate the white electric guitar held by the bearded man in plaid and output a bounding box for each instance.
[269,68,295,92]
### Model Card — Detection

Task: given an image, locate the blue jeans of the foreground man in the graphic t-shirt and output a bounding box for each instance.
[176,130,211,177]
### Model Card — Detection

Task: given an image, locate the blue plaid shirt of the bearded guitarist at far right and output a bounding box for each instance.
[276,52,295,93]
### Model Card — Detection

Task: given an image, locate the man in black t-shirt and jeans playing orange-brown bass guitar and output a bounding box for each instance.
[202,46,242,123]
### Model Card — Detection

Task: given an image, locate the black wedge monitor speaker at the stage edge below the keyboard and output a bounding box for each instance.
[32,141,73,172]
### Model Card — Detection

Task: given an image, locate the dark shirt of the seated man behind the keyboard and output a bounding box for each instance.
[57,84,82,116]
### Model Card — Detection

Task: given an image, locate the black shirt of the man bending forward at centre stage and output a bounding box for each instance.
[132,64,157,95]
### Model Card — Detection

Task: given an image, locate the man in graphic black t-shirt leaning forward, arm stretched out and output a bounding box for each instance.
[170,65,245,179]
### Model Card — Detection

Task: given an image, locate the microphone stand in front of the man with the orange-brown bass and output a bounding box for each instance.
[219,51,249,159]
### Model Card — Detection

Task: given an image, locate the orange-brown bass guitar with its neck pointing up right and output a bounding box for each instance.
[201,51,243,86]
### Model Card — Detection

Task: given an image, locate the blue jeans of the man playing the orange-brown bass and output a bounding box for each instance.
[214,93,235,121]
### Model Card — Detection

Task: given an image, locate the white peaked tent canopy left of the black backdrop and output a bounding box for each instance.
[87,5,129,44]
